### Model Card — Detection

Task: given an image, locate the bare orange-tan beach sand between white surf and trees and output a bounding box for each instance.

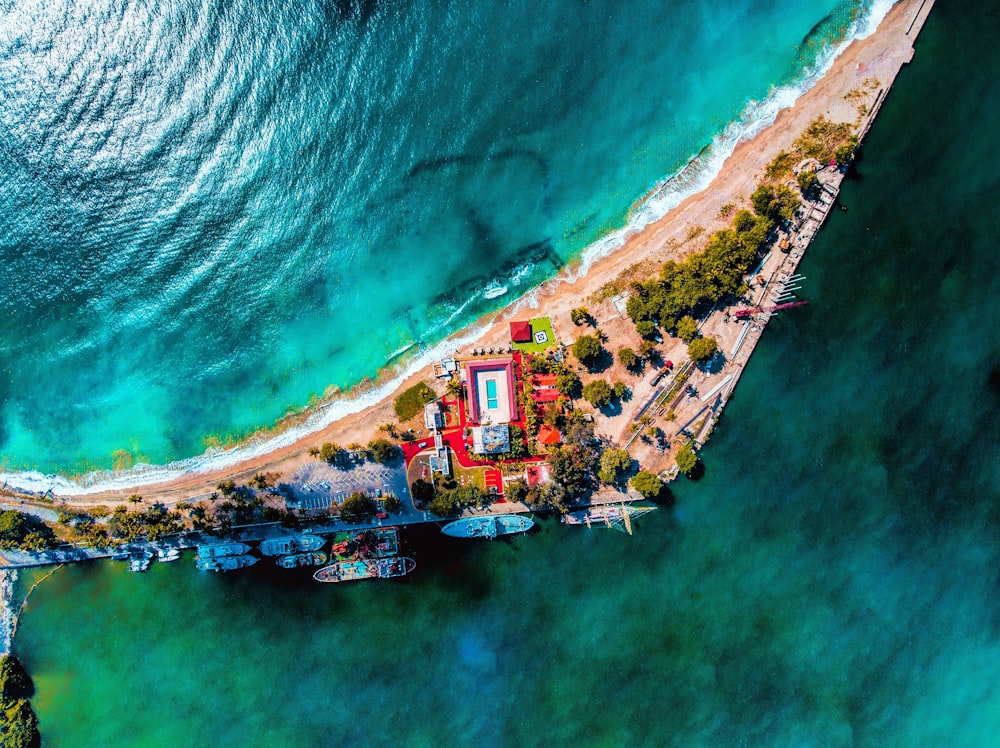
[19,0,933,504]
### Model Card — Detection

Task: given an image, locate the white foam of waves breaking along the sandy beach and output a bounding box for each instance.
[0,5,895,496]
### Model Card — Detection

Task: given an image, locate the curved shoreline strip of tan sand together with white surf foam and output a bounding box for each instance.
[0,0,933,503]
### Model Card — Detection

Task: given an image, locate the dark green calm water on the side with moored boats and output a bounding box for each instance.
[15,3,1000,747]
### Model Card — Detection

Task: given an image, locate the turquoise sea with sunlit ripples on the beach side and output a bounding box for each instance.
[0,0,884,473]
